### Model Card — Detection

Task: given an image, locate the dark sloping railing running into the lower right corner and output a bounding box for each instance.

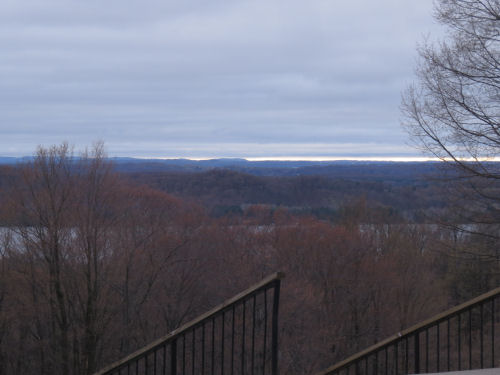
[316,287,500,375]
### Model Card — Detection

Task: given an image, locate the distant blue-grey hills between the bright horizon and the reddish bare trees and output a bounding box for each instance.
[0,157,445,220]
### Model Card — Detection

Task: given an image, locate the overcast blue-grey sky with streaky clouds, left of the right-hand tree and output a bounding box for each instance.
[0,0,436,158]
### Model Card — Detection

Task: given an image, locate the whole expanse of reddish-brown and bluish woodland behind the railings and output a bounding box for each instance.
[0,145,499,374]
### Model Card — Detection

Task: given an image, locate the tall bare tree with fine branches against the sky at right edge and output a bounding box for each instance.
[402,0,500,261]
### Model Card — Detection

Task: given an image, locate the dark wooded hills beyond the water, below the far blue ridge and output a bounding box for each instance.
[126,163,445,222]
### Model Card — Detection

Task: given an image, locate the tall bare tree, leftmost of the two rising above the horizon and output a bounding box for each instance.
[14,144,74,373]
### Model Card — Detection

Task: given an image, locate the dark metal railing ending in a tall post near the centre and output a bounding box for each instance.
[94,272,284,375]
